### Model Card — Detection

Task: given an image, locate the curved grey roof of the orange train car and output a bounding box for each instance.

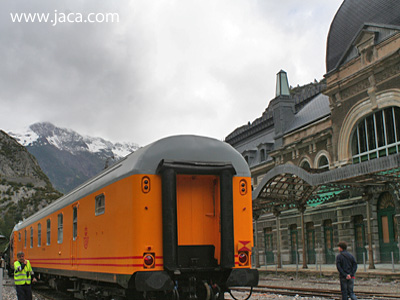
[15,135,250,230]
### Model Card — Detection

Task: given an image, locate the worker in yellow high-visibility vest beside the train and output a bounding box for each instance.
[14,252,36,300]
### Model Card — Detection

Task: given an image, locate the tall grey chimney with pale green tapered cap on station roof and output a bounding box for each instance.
[271,70,295,147]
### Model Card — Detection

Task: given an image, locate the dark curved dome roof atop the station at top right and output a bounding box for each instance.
[326,0,400,73]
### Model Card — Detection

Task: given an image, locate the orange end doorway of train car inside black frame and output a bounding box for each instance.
[176,175,221,268]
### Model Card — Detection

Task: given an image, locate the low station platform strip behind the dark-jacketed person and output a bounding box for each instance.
[253,264,400,280]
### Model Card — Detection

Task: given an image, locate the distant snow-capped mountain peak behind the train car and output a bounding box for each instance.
[9,122,139,193]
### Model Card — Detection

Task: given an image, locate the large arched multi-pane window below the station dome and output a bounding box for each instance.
[351,107,400,163]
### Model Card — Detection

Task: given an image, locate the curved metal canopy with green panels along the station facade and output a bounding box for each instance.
[253,154,400,215]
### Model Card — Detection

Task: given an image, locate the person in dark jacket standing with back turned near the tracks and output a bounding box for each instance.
[336,242,357,300]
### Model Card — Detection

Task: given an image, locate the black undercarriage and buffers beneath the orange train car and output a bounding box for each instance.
[39,269,258,300]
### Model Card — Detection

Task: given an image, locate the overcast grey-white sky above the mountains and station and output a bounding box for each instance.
[0,0,342,146]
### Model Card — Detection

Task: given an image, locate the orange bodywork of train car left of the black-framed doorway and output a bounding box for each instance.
[14,175,163,282]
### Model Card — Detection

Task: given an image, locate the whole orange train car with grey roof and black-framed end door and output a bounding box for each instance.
[10,135,258,299]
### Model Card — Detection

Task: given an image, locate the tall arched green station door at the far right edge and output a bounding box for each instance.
[378,193,399,262]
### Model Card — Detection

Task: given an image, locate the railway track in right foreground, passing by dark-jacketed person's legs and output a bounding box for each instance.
[232,285,400,300]
